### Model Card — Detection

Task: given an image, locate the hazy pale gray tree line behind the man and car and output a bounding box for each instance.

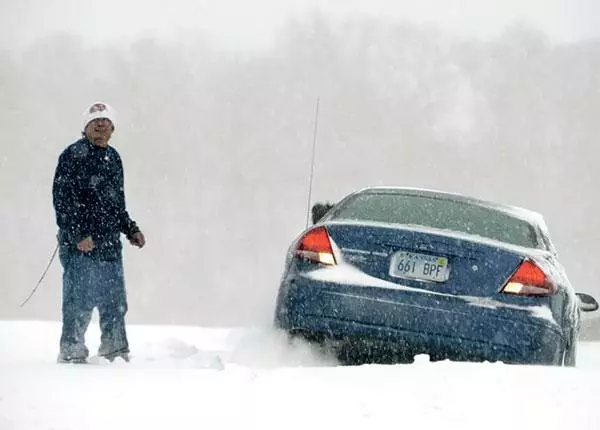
[0,15,600,324]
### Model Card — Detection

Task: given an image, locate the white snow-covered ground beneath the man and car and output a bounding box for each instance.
[0,321,600,430]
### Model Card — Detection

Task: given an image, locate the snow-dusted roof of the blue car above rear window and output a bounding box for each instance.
[352,186,547,230]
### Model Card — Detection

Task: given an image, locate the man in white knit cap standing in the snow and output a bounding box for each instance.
[52,103,145,363]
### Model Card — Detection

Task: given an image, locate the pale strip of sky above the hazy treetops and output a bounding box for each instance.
[0,0,600,49]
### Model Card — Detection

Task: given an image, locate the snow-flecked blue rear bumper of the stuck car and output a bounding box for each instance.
[275,277,565,365]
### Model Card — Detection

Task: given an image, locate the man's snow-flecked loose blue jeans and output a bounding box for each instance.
[59,246,129,358]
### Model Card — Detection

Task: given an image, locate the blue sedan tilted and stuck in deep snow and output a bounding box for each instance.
[274,187,598,366]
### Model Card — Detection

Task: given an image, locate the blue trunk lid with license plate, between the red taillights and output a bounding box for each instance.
[327,223,523,297]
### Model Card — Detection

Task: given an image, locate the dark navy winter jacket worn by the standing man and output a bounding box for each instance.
[52,138,139,260]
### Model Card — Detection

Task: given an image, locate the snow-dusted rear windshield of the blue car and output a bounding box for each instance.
[332,193,539,248]
